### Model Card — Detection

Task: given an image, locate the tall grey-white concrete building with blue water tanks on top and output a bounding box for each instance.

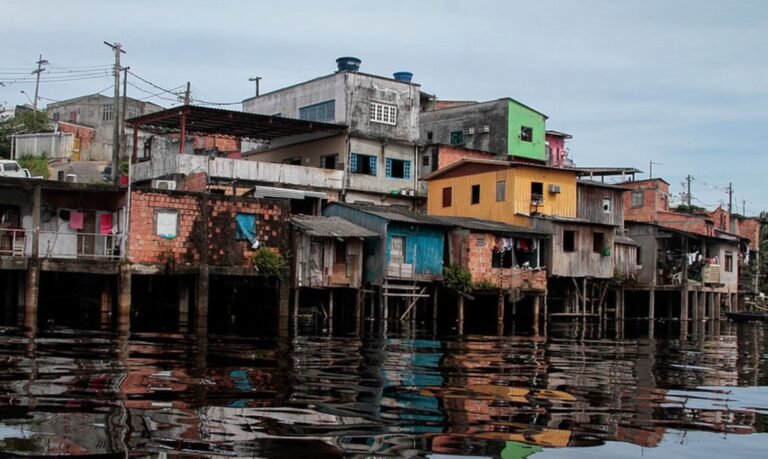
[243,58,421,205]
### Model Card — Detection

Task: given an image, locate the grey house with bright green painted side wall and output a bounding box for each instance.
[419,97,547,164]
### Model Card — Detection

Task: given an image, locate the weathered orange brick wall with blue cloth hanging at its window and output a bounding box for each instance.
[129,190,290,266]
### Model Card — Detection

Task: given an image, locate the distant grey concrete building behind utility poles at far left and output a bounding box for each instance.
[46,94,163,161]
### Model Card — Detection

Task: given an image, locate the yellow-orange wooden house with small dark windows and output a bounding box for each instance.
[424,158,577,226]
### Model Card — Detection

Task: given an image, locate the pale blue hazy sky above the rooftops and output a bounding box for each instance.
[0,0,768,215]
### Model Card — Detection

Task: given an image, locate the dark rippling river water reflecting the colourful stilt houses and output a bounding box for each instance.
[0,323,768,458]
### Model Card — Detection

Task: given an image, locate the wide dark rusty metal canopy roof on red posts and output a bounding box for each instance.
[125,105,347,141]
